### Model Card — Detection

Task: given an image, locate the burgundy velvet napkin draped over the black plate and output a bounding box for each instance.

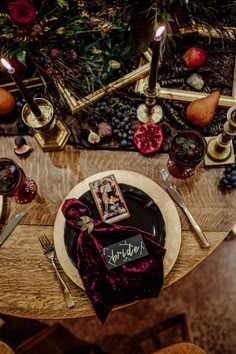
[62,198,165,322]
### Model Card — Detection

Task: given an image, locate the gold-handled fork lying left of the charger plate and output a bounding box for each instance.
[39,235,75,308]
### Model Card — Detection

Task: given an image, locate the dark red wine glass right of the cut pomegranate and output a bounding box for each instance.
[167,129,207,178]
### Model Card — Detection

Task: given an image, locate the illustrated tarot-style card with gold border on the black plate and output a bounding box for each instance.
[89,174,130,224]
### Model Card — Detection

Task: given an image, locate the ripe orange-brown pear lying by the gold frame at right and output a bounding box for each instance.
[186,91,220,127]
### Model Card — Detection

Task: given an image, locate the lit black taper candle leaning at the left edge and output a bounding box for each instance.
[1,59,42,118]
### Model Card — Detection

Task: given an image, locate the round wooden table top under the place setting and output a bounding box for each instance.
[0,137,236,319]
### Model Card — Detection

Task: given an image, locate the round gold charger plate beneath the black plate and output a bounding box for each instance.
[54,170,181,289]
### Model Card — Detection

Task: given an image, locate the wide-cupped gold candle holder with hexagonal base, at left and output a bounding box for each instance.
[21,98,70,151]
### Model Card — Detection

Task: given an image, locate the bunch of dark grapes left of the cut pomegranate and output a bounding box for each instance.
[112,104,134,147]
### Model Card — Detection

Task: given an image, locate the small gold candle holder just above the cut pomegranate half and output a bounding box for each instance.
[137,84,163,123]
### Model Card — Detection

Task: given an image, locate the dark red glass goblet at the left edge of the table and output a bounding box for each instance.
[0,158,37,204]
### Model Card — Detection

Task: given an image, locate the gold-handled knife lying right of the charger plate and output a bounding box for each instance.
[161,169,210,248]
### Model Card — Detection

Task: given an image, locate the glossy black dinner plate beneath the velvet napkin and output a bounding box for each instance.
[64,183,166,267]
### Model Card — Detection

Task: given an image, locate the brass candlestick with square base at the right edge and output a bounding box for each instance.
[204,106,236,166]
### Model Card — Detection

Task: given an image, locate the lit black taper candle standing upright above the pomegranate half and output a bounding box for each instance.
[148,26,165,92]
